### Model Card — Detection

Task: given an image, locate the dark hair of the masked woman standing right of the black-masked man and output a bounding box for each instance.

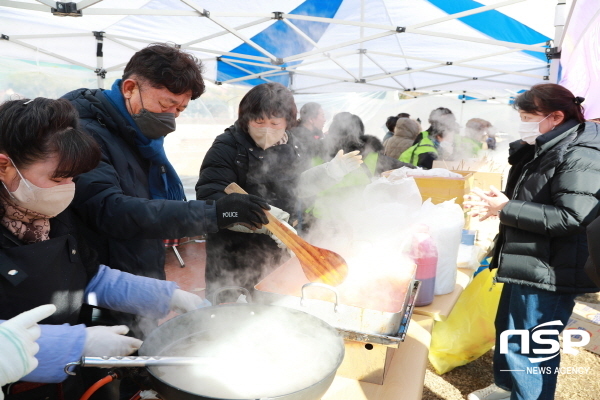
[238,82,298,132]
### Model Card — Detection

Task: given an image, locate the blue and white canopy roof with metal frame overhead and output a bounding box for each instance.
[0,0,556,97]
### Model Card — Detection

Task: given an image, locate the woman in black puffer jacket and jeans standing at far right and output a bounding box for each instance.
[465,84,600,400]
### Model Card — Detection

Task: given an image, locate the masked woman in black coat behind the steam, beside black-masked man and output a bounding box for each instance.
[196,83,362,298]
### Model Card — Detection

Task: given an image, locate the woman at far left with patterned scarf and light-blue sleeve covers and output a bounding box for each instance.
[0,98,213,400]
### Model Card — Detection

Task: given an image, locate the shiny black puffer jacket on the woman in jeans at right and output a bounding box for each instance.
[492,121,600,293]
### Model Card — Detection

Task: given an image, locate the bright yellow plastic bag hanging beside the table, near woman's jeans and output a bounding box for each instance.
[429,269,503,375]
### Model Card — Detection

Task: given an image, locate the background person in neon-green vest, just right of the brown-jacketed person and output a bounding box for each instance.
[399,107,458,169]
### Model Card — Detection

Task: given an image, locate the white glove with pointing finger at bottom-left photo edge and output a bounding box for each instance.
[0,304,56,388]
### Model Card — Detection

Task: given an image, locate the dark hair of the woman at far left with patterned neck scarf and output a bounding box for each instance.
[0,97,101,198]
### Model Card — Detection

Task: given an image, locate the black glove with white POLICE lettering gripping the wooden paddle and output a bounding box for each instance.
[216,193,271,229]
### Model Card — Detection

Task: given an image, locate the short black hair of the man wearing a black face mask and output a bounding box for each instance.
[123,43,206,100]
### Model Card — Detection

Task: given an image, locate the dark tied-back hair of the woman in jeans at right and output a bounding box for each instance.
[513,83,585,122]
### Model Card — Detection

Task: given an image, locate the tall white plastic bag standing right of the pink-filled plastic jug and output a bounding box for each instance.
[419,200,465,295]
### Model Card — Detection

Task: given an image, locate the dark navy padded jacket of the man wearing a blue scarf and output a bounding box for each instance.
[63,89,217,279]
